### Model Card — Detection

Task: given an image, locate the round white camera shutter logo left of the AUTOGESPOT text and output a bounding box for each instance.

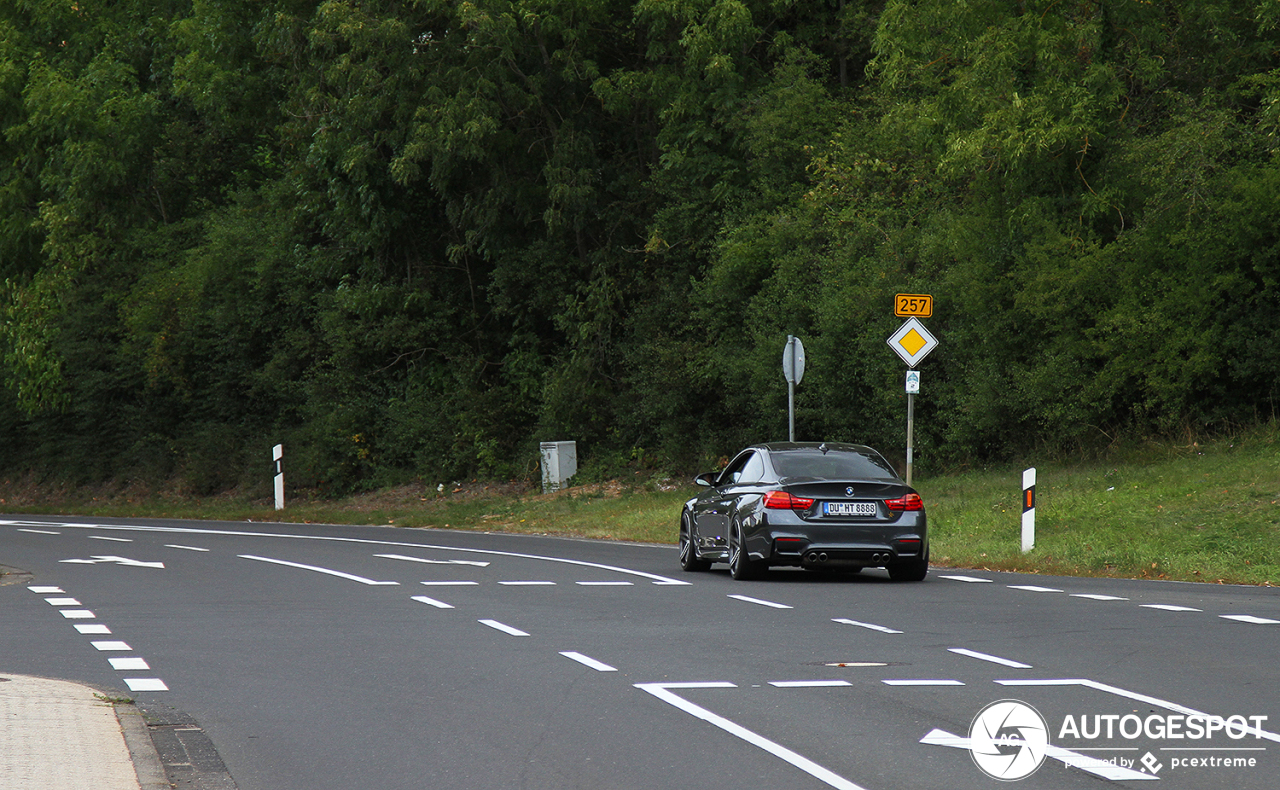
[969,699,1048,781]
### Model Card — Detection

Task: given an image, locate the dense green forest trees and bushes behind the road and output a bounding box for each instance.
[0,0,1280,493]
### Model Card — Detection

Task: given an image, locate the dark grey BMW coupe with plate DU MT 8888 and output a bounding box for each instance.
[680,442,929,581]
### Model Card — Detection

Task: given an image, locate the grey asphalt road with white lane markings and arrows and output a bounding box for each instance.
[0,516,1280,790]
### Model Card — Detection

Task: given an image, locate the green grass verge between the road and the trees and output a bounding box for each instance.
[0,424,1280,585]
